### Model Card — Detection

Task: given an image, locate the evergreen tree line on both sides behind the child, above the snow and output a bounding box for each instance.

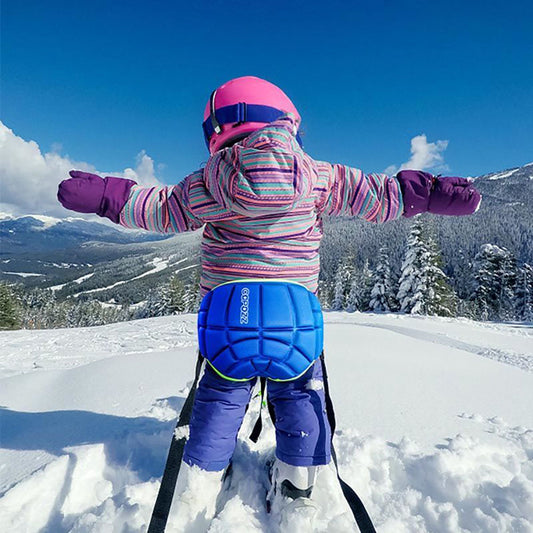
[0,217,533,329]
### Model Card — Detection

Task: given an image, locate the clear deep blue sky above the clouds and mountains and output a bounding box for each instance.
[1,0,533,191]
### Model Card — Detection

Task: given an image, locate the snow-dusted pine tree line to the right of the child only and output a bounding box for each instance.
[319,217,533,322]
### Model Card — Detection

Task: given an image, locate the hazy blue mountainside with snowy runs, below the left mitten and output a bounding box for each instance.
[0,216,199,303]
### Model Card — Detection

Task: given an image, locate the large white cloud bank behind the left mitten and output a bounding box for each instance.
[0,121,161,218]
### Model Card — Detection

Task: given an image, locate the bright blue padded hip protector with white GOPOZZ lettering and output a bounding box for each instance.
[198,279,324,381]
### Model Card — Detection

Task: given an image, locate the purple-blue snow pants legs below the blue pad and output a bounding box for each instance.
[183,360,331,471]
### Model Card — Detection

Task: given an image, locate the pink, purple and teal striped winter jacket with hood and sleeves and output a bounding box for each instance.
[120,115,403,294]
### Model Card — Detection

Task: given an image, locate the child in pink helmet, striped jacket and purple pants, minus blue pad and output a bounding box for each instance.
[58,76,481,528]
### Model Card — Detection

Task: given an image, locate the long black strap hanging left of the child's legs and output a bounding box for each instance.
[147,353,204,533]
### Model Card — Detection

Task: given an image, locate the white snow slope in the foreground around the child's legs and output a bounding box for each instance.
[0,313,533,533]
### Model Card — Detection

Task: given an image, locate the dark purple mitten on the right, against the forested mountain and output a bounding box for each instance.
[396,170,481,218]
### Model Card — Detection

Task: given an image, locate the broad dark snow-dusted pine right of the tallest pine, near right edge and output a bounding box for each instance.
[472,244,517,320]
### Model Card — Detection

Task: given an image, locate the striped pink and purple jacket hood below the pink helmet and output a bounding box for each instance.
[204,114,317,217]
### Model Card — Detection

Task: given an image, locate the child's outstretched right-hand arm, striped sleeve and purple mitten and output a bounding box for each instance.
[323,165,481,223]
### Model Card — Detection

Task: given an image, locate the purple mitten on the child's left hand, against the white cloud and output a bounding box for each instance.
[57,170,137,223]
